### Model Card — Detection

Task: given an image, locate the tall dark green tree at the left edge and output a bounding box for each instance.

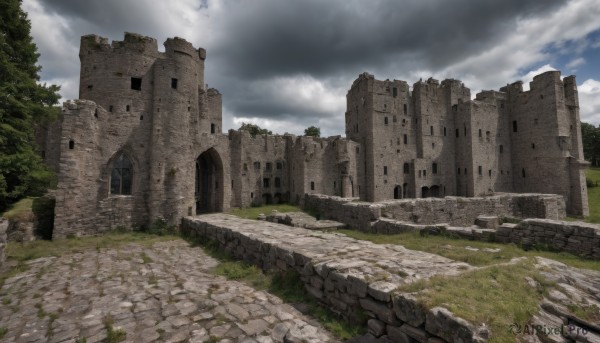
[0,0,60,211]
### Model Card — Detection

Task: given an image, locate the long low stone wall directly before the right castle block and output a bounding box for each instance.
[304,193,566,231]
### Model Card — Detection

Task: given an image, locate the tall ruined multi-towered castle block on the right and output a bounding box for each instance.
[346,72,589,215]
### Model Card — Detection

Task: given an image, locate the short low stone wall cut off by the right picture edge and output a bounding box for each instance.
[495,219,600,259]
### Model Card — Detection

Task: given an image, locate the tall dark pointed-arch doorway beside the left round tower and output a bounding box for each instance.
[195,148,224,214]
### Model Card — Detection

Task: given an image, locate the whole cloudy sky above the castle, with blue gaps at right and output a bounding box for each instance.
[23,0,600,135]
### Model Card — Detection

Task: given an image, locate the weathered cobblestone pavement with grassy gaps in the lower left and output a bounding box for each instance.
[0,240,336,343]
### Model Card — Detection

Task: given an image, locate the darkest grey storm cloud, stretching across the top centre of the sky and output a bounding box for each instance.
[212,0,563,78]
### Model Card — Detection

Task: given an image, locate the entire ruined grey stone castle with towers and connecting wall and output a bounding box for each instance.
[37,33,589,237]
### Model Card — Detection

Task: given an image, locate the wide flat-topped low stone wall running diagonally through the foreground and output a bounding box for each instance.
[182,214,490,343]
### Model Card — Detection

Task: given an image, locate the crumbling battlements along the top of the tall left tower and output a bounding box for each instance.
[80,32,206,60]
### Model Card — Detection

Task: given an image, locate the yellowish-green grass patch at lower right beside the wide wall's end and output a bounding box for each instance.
[398,259,554,342]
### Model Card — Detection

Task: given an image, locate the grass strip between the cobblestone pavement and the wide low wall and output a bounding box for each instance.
[185,235,366,340]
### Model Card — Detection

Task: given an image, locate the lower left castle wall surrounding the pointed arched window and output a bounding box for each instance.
[53,100,148,238]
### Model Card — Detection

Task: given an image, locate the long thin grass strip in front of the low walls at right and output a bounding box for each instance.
[337,230,600,271]
